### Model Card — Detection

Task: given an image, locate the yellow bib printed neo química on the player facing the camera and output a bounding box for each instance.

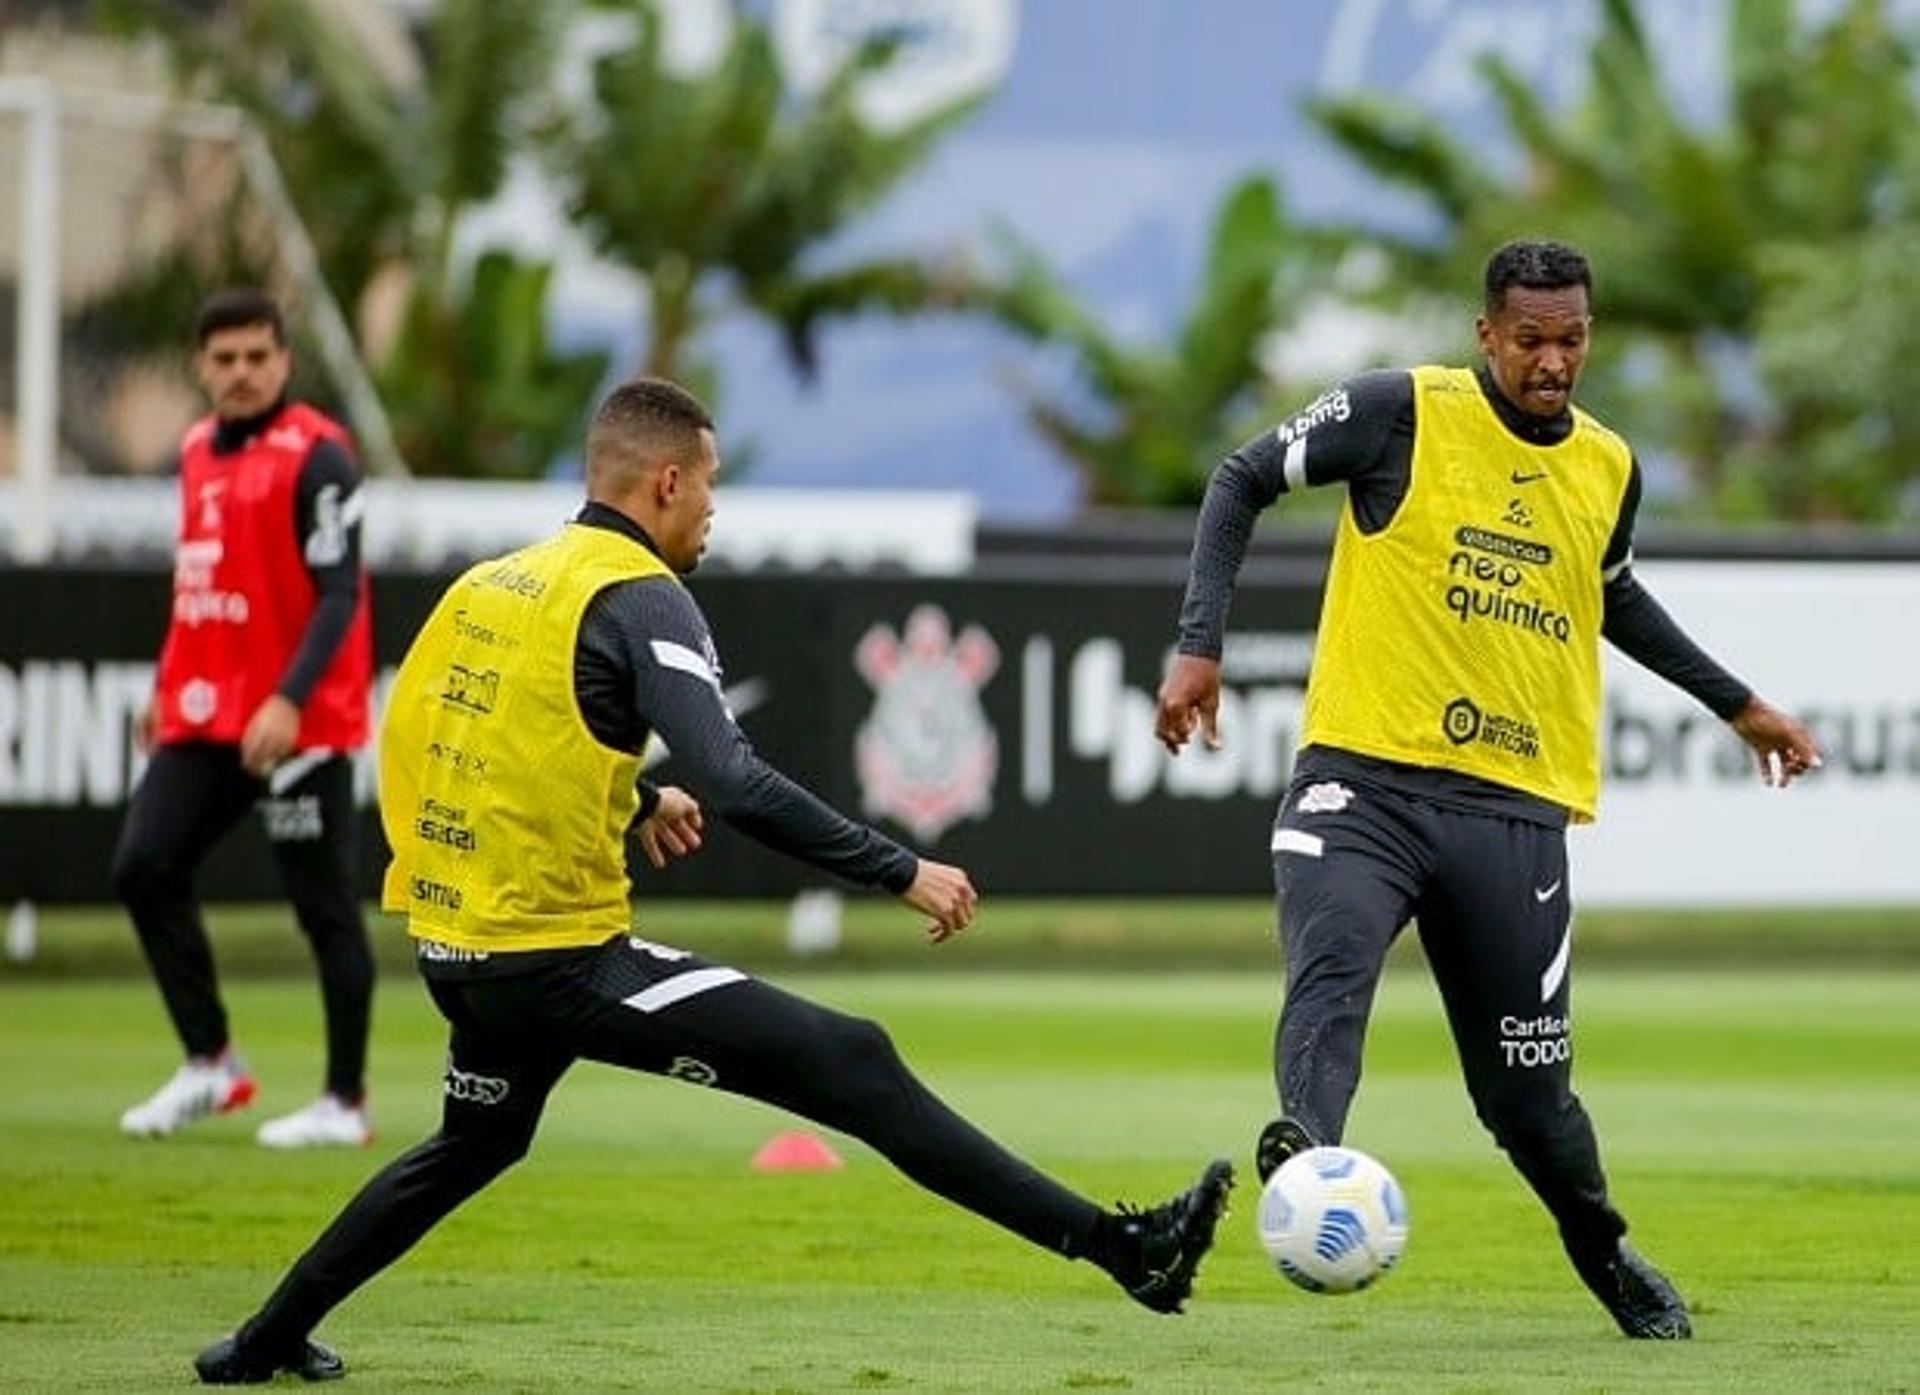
[1300,368,1632,821]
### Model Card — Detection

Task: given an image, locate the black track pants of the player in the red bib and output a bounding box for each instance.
[113,743,372,1099]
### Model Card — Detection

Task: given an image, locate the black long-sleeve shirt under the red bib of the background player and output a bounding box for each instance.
[202,397,365,706]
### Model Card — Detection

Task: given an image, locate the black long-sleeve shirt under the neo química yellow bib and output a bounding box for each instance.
[1179,368,1753,823]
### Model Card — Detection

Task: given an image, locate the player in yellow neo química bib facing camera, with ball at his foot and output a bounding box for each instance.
[1156,242,1820,1337]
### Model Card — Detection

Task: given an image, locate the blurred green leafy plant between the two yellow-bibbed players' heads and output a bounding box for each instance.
[979,175,1323,505]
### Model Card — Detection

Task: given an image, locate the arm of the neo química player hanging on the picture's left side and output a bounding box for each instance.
[1154,372,1413,752]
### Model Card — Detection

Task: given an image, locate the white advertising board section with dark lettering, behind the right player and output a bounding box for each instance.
[1571,562,1920,906]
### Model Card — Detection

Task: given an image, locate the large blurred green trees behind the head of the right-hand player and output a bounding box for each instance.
[1311,0,1920,520]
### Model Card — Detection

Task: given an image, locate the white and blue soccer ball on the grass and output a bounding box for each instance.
[1258,1147,1407,1293]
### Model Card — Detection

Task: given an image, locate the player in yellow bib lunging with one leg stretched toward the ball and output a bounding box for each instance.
[194,378,1233,1383]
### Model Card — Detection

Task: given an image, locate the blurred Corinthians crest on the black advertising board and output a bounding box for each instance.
[852,604,1000,842]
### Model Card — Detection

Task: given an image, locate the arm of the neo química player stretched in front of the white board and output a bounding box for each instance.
[1601,461,1820,785]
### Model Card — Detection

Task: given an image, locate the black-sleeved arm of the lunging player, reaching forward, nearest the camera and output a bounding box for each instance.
[582,581,977,940]
